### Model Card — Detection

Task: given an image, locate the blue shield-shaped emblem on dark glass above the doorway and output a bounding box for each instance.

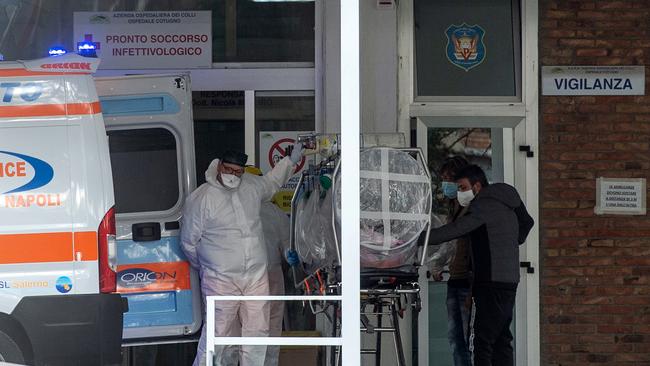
[446,23,485,71]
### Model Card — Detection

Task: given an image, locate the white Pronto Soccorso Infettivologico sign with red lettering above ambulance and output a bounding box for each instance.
[73,11,212,69]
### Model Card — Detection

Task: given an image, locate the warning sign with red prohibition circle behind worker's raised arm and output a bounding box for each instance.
[260,131,309,212]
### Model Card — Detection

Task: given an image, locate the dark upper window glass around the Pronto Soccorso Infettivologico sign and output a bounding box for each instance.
[0,0,315,62]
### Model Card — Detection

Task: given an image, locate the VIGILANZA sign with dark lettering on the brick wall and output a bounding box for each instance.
[542,66,645,95]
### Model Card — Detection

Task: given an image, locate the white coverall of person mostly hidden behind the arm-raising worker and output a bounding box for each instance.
[260,202,290,366]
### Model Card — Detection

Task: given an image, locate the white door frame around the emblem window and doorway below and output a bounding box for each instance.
[397,0,540,366]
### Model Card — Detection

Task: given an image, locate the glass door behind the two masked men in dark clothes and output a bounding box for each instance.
[416,117,526,366]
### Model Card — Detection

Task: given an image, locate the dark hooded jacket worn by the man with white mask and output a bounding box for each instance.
[431,183,534,289]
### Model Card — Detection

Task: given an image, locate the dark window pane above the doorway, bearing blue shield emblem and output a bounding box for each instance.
[414,0,521,101]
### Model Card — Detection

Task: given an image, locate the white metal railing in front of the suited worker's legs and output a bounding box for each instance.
[205,295,343,366]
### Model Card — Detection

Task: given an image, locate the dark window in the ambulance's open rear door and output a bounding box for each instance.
[108,128,179,213]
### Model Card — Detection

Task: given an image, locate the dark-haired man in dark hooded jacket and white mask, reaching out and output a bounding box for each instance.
[431,165,533,366]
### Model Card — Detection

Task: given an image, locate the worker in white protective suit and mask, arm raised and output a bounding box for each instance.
[181,145,302,366]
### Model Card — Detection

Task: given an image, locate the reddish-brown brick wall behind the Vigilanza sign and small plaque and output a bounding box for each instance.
[540,0,650,365]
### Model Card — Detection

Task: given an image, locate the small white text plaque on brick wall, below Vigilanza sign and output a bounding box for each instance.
[594,177,646,215]
